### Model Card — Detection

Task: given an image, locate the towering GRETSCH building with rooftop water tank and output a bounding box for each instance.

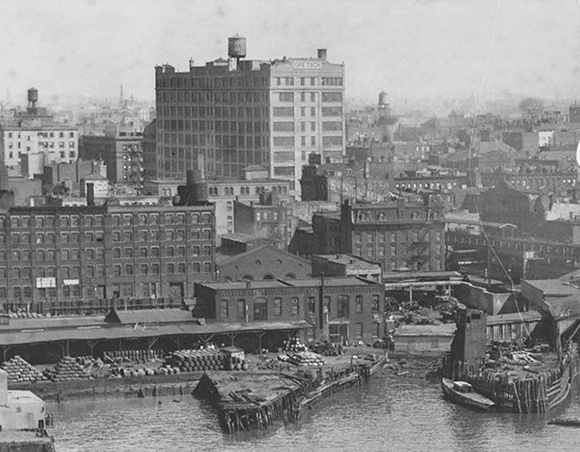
[153,37,345,195]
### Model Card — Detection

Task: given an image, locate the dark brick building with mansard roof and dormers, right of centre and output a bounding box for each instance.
[308,195,445,272]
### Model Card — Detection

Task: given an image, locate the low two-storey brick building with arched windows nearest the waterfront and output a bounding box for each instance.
[195,277,384,342]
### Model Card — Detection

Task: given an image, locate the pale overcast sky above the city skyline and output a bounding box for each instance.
[0,0,580,103]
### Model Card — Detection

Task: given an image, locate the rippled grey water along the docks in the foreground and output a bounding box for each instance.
[47,372,580,452]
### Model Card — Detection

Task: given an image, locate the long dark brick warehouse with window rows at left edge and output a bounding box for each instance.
[0,204,215,307]
